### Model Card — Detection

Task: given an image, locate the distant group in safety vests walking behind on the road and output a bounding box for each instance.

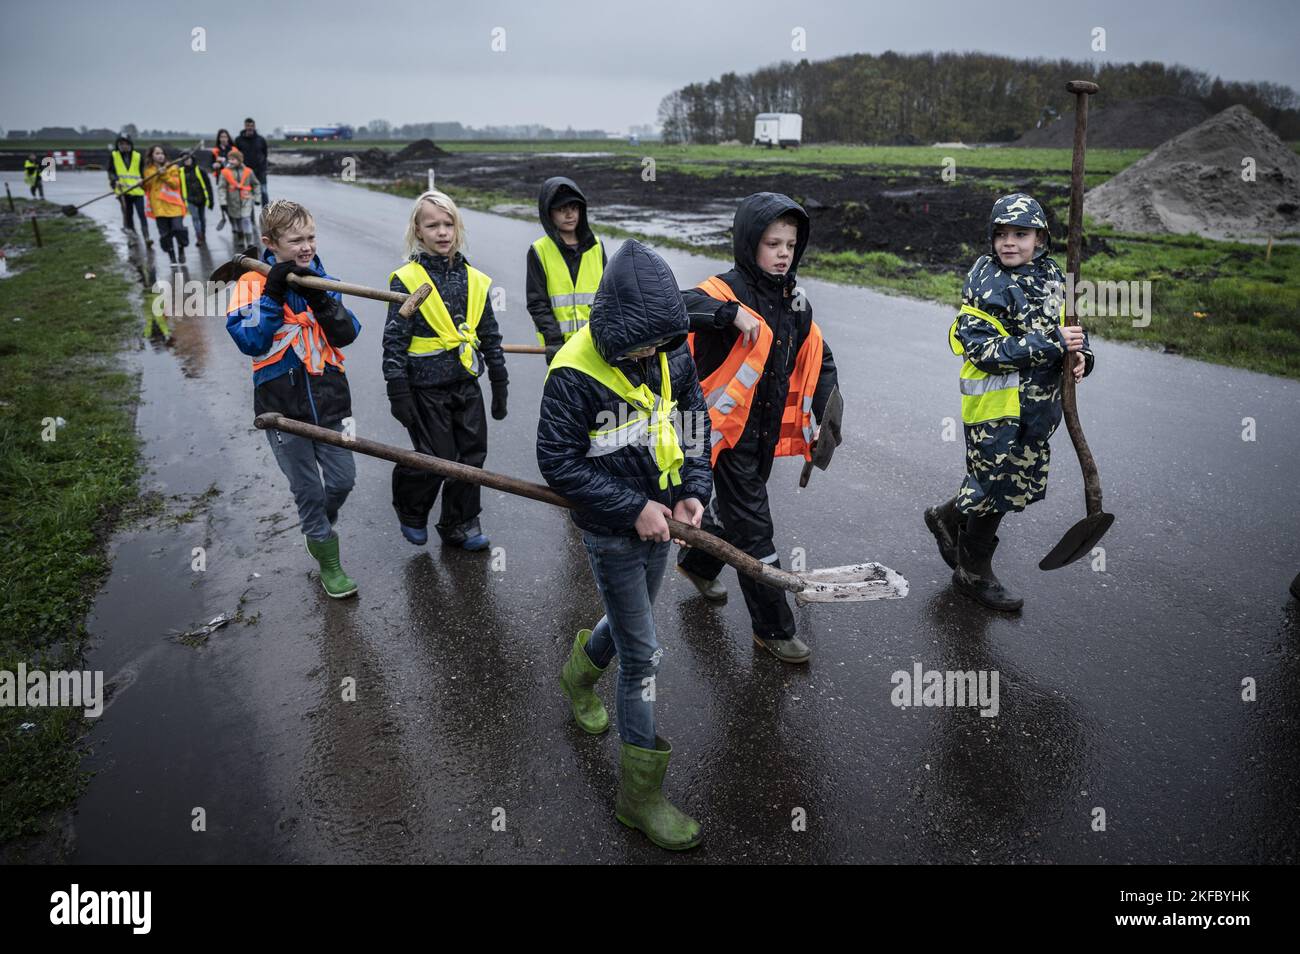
[107,130,263,265]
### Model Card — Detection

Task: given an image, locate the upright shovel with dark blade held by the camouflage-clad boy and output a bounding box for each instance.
[1039,79,1115,569]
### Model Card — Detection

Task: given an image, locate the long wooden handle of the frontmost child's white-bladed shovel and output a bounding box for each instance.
[254,413,806,593]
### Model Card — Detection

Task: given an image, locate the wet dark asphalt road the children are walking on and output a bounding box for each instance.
[5,171,1300,863]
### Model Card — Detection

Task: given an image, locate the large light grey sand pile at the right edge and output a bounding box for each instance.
[1084,105,1300,239]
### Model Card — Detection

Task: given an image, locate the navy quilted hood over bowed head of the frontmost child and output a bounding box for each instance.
[589,239,690,364]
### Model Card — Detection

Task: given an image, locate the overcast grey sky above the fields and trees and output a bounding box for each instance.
[0,0,1300,133]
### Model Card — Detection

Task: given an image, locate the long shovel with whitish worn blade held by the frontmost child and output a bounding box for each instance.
[254,413,907,606]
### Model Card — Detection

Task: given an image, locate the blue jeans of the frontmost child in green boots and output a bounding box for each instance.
[582,532,671,749]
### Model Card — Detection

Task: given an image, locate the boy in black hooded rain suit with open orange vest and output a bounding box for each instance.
[677,192,840,663]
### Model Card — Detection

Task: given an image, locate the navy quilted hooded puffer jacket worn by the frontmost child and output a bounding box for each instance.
[537,240,712,537]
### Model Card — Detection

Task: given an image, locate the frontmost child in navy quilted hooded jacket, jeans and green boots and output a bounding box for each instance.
[537,242,711,850]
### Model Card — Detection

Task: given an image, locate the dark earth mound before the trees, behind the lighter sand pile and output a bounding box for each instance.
[1011,96,1210,149]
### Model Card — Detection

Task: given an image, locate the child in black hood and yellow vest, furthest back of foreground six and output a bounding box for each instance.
[527,175,606,364]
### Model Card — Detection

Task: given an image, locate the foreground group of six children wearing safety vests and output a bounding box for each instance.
[228,178,1093,850]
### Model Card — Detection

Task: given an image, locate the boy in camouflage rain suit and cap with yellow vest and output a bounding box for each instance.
[926,192,1093,612]
